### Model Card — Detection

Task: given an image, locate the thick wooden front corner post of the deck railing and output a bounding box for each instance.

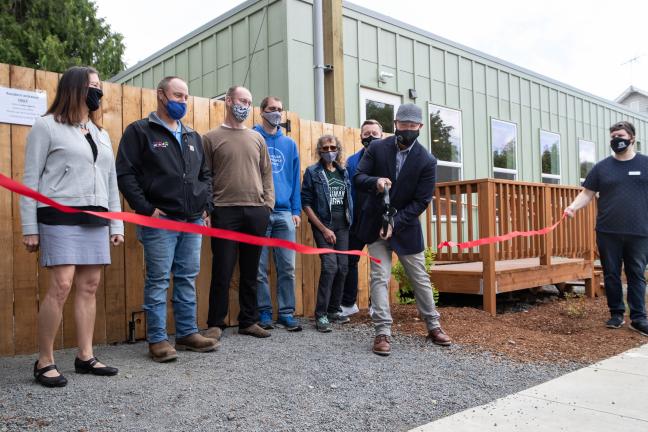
[477,180,497,316]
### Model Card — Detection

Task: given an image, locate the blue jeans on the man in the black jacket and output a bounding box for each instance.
[137,218,203,343]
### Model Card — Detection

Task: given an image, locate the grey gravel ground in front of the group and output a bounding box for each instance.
[0,323,580,432]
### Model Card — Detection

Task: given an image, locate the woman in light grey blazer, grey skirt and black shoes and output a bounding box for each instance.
[20,67,124,387]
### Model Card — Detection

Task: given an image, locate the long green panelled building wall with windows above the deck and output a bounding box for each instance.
[340,0,648,184]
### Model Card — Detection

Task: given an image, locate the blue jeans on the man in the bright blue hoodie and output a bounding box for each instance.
[257,211,295,316]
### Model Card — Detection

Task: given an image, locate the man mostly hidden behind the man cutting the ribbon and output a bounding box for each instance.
[340,119,382,316]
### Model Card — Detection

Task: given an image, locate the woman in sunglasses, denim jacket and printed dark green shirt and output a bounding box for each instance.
[301,135,353,333]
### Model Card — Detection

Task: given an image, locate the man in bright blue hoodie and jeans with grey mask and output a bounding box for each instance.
[254,96,302,332]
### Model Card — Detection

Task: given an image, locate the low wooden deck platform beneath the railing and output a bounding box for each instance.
[430,257,593,295]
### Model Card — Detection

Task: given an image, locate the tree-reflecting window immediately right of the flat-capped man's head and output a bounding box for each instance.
[429,104,463,182]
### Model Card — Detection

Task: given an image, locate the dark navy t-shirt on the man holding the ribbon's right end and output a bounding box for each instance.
[583,153,648,237]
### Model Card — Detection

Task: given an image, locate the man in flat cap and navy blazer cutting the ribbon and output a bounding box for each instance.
[354,104,452,356]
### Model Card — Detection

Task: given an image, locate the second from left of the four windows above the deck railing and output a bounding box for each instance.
[491,119,517,180]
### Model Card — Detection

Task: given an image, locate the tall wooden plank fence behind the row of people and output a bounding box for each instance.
[0,64,369,356]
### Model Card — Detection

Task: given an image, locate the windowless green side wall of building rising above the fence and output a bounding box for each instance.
[116,0,288,107]
